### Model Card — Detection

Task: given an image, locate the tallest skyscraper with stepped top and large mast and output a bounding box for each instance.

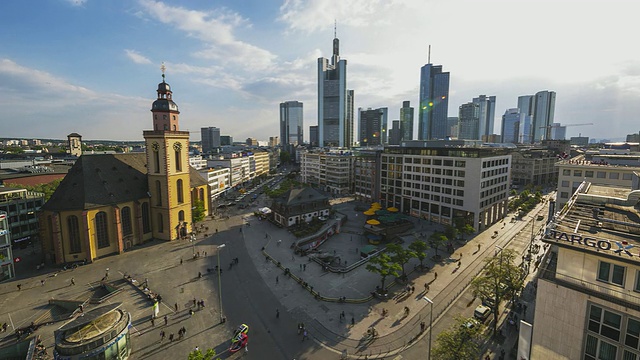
[318,31,353,147]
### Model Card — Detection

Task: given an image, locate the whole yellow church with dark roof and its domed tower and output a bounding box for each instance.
[39,69,210,264]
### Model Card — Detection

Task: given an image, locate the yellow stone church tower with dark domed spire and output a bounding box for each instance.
[143,64,192,240]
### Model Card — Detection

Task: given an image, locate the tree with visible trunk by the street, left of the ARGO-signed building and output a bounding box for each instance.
[471,249,525,334]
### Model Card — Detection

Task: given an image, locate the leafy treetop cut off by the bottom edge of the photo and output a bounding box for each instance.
[431,315,483,360]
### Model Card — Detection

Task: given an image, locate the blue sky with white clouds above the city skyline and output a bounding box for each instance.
[0,0,640,141]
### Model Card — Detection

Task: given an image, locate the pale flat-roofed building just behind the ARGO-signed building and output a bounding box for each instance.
[555,149,640,209]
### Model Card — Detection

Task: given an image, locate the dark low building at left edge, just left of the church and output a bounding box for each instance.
[0,187,44,248]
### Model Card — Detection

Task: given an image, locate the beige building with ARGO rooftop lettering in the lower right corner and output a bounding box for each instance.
[530,180,640,360]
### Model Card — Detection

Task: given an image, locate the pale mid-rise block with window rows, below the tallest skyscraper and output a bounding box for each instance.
[300,150,354,194]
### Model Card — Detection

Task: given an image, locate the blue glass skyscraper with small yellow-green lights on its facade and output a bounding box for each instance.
[418,63,449,140]
